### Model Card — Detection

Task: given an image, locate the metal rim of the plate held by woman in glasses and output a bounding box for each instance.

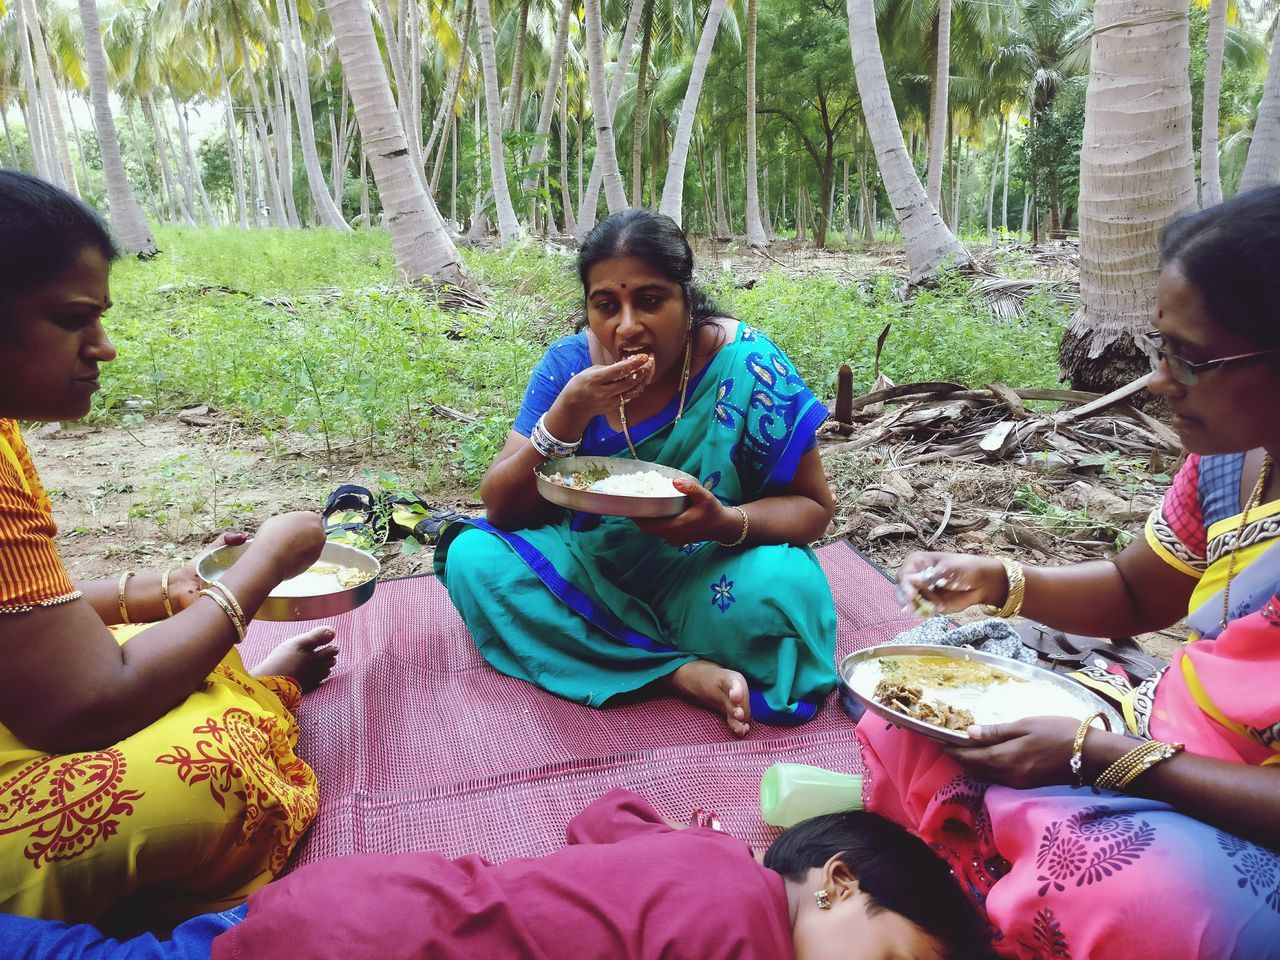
[840,644,1124,745]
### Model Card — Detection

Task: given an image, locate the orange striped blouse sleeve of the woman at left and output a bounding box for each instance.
[0,420,81,613]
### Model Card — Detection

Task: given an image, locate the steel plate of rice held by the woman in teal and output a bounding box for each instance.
[534,457,698,518]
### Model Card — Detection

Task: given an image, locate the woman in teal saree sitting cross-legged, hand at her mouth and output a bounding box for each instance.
[435,210,836,736]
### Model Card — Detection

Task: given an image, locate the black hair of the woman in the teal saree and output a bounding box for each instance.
[577,207,724,326]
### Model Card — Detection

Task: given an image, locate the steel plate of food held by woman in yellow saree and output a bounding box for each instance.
[196,543,381,621]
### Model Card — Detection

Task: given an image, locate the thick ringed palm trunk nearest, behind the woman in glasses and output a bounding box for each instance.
[1060,0,1196,392]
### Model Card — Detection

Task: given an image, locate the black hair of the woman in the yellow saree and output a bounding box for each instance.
[0,170,119,313]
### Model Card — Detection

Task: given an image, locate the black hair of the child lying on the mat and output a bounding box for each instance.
[764,810,993,960]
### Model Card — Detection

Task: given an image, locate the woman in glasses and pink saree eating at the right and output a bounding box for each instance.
[885,187,1280,960]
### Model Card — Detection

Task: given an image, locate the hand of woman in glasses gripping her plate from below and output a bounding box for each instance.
[947,717,1080,790]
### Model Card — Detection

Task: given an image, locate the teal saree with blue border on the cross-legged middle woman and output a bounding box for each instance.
[435,324,836,724]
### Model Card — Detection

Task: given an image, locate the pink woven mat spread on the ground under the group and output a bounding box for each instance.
[243,543,915,863]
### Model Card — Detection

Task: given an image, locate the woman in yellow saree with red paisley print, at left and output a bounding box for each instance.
[0,172,337,927]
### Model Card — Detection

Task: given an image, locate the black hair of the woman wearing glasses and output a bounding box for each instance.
[1160,184,1280,348]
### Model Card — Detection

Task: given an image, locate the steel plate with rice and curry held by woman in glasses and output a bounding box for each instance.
[840,644,1124,744]
